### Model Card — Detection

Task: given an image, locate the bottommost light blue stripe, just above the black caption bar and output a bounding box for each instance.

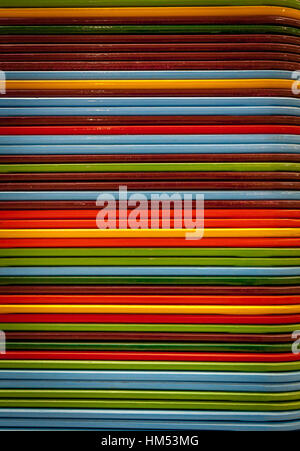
[0,416,300,431]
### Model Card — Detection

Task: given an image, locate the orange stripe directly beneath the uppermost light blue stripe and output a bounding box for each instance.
[6,78,294,89]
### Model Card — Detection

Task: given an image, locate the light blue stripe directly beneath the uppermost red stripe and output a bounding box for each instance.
[0,133,300,145]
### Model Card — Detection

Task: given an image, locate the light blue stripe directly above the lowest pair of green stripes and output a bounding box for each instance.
[0,380,300,393]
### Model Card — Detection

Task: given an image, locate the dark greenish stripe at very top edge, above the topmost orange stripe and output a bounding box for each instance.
[1,0,300,9]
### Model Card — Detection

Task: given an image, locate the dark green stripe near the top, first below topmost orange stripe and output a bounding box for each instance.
[0,25,300,35]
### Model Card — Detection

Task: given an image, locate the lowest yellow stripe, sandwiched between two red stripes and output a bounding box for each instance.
[0,305,300,315]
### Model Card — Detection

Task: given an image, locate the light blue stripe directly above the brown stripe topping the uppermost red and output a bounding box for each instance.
[0,106,300,117]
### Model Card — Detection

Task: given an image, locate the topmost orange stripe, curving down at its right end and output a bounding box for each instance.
[0,6,300,19]
